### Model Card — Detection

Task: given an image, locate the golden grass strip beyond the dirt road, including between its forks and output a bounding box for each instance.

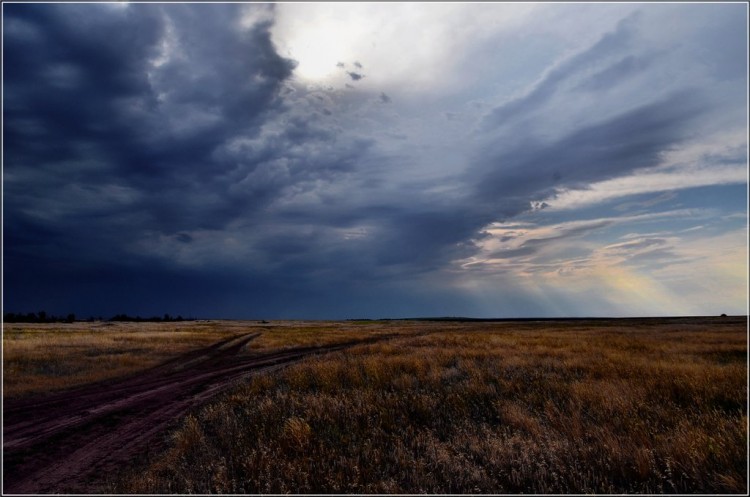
[3,321,414,398]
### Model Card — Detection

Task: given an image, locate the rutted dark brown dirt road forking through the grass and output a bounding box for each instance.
[3,334,386,494]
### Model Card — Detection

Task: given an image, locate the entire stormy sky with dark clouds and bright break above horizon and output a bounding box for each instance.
[2,3,748,319]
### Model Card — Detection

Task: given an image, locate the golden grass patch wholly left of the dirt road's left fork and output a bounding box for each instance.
[3,321,250,398]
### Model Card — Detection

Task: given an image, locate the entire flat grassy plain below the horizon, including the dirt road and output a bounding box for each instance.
[3,317,748,493]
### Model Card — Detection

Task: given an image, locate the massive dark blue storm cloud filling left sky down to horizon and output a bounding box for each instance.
[4,4,418,316]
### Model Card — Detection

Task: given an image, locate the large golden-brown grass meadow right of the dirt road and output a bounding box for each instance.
[113,318,748,494]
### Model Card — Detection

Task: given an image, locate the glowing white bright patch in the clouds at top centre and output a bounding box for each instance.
[273,3,536,91]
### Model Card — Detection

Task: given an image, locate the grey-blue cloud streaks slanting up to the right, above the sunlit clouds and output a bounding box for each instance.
[471,13,715,223]
